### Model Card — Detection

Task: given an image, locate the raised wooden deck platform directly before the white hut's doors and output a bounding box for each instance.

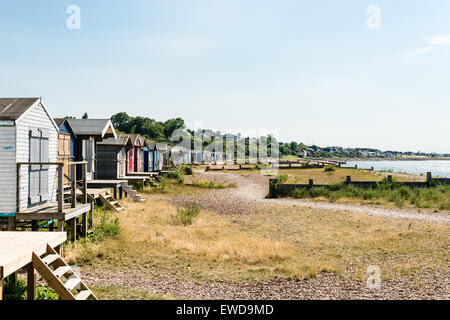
[16,202,91,221]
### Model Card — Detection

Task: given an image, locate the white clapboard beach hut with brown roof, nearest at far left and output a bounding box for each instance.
[0,98,58,217]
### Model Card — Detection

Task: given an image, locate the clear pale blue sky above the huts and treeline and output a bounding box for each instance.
[0,0,450,153]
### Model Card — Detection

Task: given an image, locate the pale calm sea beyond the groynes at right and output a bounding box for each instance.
[345,160,450,178]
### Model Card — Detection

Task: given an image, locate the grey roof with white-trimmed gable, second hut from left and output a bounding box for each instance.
[67,119,117,139]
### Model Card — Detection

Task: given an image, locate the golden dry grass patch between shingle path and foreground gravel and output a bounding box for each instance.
[66,196,450,281]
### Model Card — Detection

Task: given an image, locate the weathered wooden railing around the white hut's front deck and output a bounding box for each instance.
[16,161,88,213]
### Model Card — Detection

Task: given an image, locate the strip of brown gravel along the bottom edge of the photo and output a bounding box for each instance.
[82,269,450,300]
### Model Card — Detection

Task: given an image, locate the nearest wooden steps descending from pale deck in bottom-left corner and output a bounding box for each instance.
[33,245,97,300]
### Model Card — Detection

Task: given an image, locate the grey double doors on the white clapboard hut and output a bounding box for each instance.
[28,129,49,206]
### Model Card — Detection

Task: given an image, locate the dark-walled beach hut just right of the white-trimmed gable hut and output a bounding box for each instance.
[97,134,133,180]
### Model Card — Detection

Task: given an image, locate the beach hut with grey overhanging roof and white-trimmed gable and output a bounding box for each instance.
[67,119,117,180]
